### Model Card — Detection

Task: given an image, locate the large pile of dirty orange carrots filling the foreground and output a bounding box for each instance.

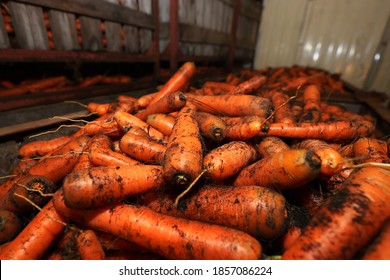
[0,62,390,260]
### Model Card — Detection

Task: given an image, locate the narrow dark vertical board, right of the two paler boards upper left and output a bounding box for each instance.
[80,16,103,51]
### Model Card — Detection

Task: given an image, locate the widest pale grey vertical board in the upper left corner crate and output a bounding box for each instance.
[8,2,49,50]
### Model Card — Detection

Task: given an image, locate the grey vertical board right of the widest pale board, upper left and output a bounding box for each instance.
[49,10,80,50]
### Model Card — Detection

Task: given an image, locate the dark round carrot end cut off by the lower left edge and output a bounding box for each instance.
[0,209,22,244]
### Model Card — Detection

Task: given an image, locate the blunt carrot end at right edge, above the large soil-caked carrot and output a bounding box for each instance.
[352,137,390,163]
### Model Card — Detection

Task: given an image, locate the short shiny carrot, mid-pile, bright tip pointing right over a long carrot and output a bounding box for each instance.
[221,115,268,141]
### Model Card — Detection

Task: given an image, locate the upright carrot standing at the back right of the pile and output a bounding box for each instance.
[300,85,321,123]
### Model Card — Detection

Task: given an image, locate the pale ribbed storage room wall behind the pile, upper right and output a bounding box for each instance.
[254,0,390,96]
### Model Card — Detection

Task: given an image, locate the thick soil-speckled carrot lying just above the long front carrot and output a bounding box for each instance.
[144,185,289,240]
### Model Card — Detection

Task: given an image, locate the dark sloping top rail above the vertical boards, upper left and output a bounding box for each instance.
[14,0,154,29]
